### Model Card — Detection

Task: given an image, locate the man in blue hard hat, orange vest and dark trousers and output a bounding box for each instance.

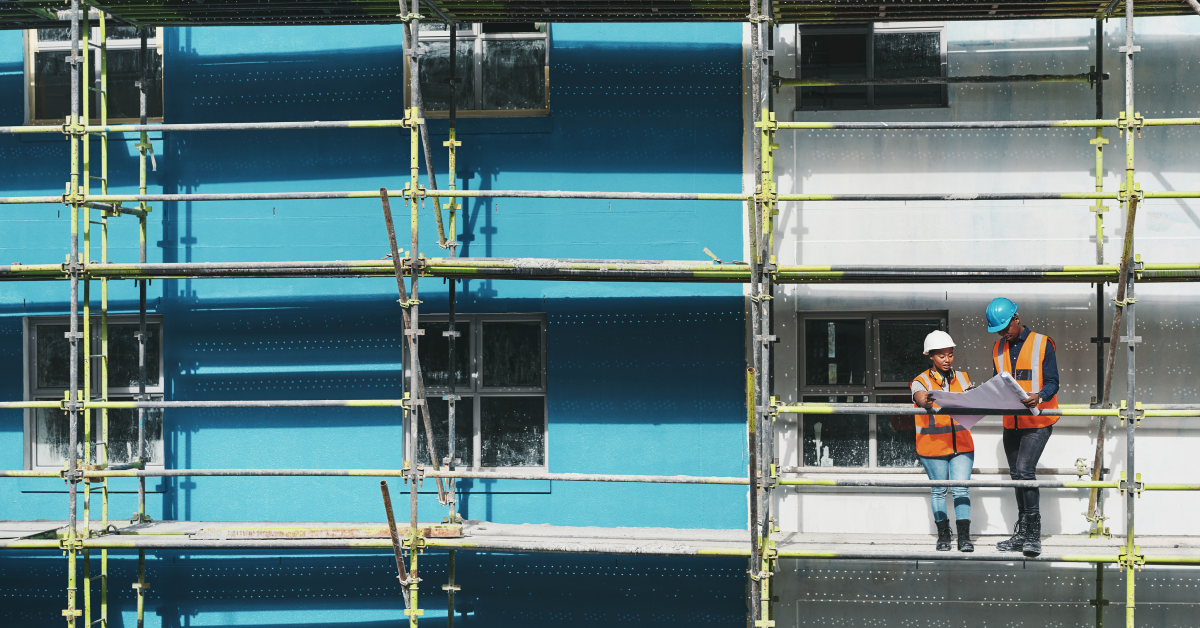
[986,297,1058,556]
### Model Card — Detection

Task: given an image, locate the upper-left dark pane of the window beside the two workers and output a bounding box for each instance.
[804,319,866,385]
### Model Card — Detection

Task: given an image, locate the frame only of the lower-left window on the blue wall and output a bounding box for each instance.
[22,313,167,471]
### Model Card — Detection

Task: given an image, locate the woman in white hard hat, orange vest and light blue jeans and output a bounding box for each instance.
[910,331,974,551]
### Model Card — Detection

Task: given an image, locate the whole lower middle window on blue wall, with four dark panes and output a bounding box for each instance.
[406,315,546,468]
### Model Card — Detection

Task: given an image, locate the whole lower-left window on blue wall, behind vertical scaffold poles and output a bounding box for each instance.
[25,316,163,468]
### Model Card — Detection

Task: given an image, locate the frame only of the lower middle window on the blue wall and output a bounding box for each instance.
[404,313,550,473]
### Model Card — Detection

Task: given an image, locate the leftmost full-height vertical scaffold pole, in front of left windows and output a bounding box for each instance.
[62,0,83,628]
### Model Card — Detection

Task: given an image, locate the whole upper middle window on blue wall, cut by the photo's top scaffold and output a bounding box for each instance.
[404,22,550,118]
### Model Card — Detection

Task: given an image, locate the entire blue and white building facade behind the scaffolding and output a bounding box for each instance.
[0,8,1200,627]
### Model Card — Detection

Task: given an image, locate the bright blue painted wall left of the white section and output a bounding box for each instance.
[0,25,746,626]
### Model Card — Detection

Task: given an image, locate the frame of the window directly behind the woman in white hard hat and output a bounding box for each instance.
[796,310,950,472]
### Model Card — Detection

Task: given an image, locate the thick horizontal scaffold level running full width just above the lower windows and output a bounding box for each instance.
[0,257,1200,283]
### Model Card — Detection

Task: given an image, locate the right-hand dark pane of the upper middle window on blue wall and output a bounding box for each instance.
[484,38,546,109]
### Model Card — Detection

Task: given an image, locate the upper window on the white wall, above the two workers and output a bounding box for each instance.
[797,24,948,110]
